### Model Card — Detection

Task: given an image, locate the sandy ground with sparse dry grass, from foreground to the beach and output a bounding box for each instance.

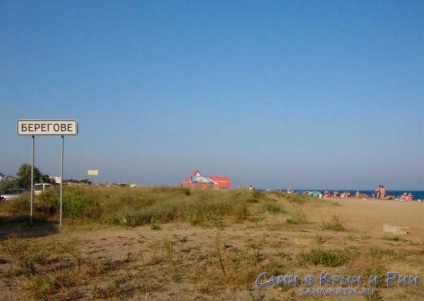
[0,197,424,300]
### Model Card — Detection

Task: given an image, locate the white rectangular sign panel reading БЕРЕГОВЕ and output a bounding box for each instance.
[18,119,78,136]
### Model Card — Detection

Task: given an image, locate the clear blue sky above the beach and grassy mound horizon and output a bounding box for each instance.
[0,0,424,190]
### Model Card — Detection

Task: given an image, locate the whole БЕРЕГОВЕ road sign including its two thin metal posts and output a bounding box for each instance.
[17,119,78,226]
